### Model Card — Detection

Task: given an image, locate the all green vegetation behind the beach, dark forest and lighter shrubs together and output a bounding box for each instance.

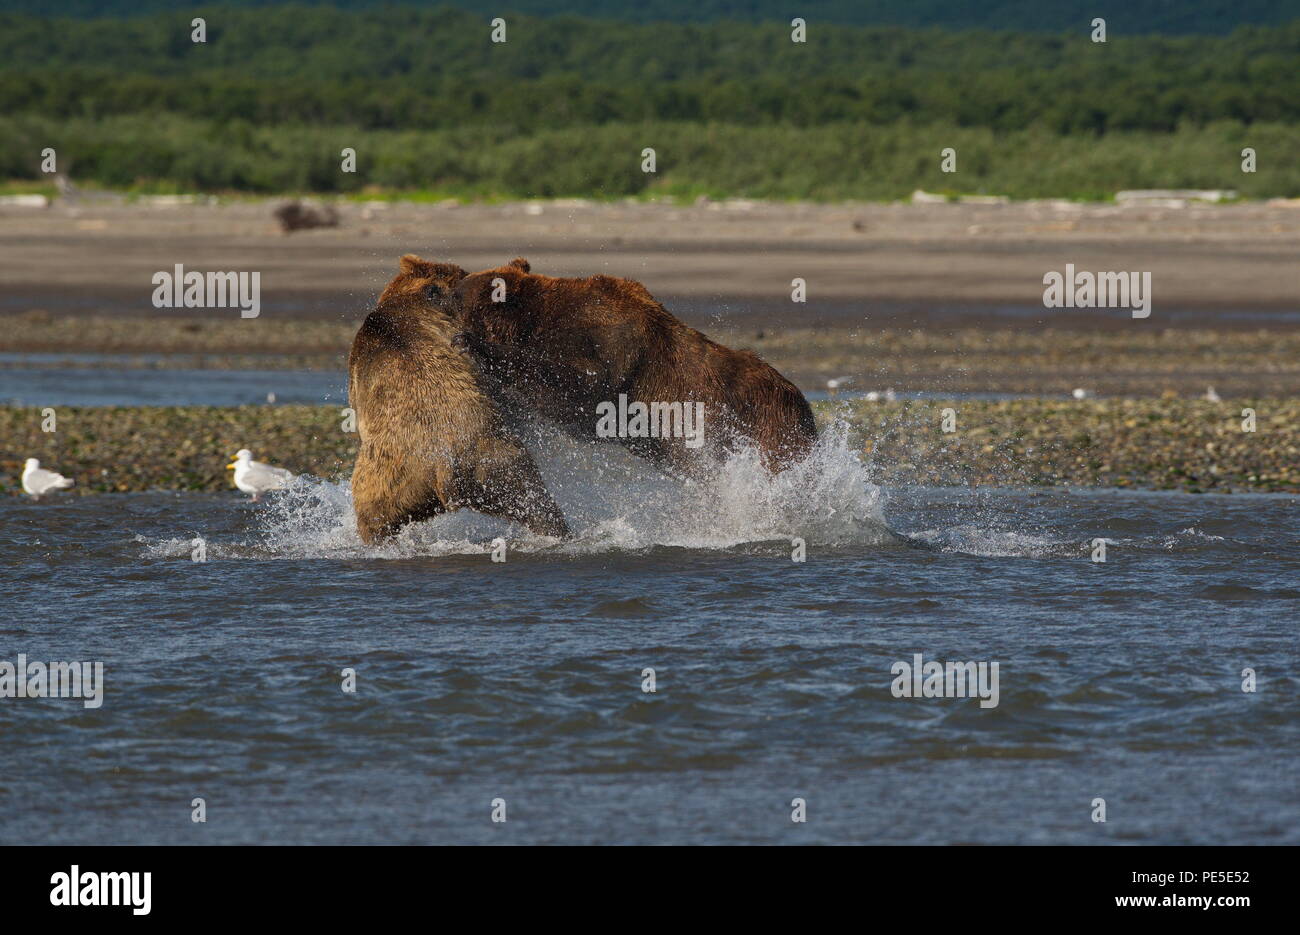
[0,5,1300,199]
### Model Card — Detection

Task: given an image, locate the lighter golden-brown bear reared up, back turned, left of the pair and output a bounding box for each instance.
[348,256,569,542]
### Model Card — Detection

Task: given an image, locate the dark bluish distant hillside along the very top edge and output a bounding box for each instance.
[5,0,1296,35]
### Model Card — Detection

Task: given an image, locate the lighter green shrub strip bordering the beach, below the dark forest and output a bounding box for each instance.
[0,116,1300,200]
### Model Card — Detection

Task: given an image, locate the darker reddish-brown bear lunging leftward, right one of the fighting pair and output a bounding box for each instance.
[389,257,816,476]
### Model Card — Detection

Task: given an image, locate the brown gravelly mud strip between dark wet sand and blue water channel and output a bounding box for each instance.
[0,318,1300,404]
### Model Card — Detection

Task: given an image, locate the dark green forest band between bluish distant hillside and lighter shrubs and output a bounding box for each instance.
[0,7,1300,134]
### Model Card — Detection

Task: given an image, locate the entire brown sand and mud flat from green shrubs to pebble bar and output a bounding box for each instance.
[0,199,1300,397]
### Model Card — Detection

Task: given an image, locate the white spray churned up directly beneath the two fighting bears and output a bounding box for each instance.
[151,423,900,558]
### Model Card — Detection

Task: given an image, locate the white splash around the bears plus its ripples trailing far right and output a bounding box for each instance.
[139,420,1225,559]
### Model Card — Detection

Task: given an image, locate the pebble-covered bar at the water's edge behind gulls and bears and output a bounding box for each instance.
[0,398,1300,495]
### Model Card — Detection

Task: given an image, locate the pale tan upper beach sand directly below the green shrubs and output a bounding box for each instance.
[0,200,1300,319]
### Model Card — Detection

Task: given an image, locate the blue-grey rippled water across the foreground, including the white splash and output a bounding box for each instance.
[0,432,1300,844]
